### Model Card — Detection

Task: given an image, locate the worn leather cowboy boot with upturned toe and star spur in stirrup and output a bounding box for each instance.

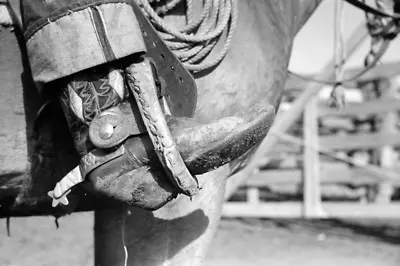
[49,53,275,209]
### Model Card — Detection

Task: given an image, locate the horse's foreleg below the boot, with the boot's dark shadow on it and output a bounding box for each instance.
[95,167,229,266]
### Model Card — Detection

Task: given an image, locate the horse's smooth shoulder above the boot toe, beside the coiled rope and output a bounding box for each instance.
[195,1,319,121]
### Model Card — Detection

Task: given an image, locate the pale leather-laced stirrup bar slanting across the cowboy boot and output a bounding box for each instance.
[125,59,199,197]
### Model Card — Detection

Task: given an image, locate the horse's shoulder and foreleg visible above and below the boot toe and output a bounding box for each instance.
[95,0,320,266]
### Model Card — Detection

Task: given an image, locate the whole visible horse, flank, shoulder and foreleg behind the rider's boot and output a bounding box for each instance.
[0,0,396,266]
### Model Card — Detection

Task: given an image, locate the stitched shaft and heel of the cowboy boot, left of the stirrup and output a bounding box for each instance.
[50,58,178,209]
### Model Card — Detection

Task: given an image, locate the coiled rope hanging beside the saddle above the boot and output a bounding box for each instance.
[136,0,238,72]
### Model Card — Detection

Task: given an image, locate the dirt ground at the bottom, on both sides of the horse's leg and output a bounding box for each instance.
[0,213,400,266]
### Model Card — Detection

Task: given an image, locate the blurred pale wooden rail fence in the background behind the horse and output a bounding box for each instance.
[223,22,400,218]
